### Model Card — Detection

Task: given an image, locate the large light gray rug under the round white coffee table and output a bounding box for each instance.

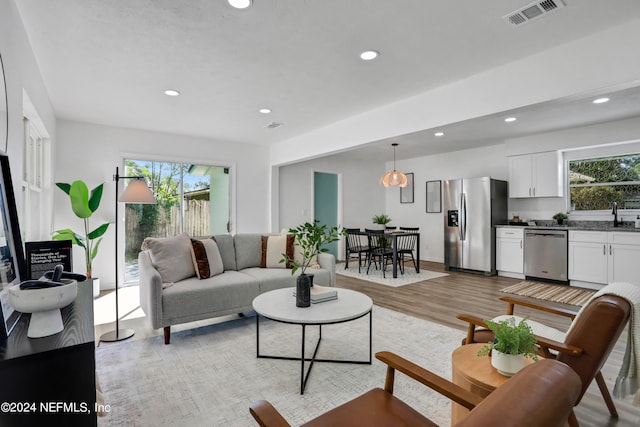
[96,306,463,427]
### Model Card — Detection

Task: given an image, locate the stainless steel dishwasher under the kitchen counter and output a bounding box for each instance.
[524,229,568,282]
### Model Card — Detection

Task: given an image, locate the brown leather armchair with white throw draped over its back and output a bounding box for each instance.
[458,295,631,427]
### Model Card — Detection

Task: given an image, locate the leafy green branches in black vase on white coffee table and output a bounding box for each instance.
[280,221,344,307]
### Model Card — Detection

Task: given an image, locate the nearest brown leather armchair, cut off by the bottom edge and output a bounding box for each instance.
[250,352,580,427]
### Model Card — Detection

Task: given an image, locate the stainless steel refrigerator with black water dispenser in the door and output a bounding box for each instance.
[442,177,508,275]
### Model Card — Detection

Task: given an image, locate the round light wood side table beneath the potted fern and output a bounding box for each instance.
[451,344,534,425]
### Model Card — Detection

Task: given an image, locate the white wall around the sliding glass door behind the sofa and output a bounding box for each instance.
[54,120,269,288]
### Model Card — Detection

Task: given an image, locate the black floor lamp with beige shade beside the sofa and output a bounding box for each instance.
[100,167,157,342]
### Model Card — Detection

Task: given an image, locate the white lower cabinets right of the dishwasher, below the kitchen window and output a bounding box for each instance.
[569,230,640,285]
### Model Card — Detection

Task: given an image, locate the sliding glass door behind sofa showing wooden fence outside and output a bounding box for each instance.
[124,159,230,282]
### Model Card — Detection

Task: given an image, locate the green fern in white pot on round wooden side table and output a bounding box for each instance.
[478,317,538,377]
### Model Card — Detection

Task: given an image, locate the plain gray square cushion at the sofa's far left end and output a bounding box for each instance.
[142,233,196,283]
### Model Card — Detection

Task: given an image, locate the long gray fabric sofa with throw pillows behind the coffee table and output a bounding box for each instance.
[138,233,335,344]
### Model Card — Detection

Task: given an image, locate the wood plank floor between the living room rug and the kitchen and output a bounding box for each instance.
[337,261,640,427]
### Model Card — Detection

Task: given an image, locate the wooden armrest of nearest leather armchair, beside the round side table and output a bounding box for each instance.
[376,351,483,409]
